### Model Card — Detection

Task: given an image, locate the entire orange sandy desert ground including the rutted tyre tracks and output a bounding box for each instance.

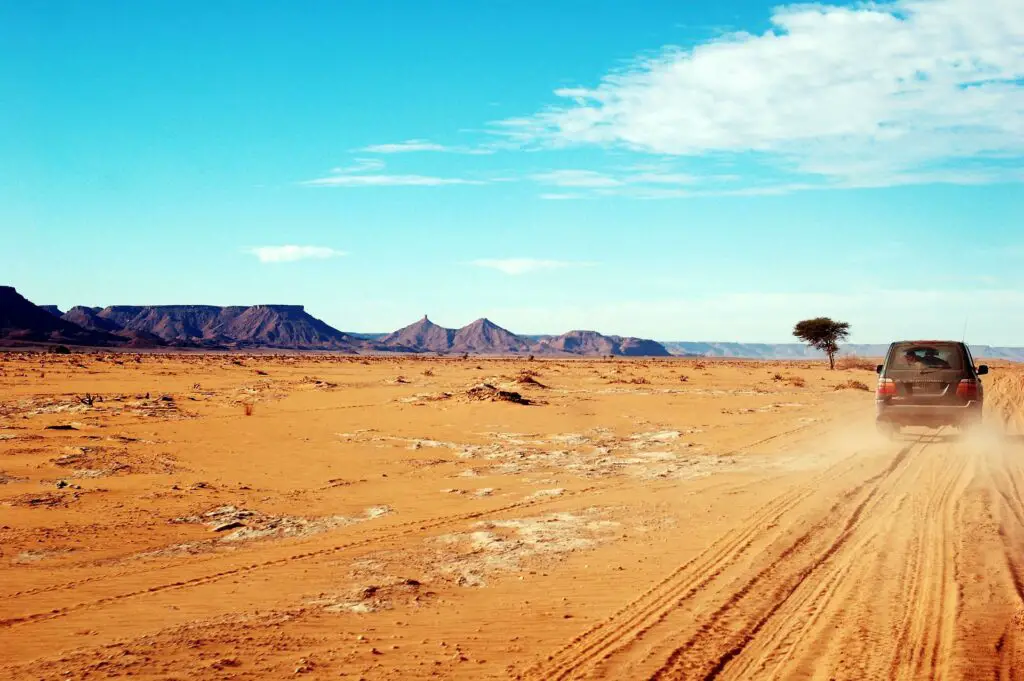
[0,353,1024,679]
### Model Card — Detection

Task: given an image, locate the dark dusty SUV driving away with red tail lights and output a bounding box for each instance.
[874,341,988,435]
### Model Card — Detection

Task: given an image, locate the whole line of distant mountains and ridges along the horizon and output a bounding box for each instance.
[6,286,1024,361]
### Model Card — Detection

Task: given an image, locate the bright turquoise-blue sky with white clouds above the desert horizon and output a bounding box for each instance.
[0,0,1024,345]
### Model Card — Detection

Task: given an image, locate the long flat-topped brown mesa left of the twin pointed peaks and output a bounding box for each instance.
[90,305,368,351]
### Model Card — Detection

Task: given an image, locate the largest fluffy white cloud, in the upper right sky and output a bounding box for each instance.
[499,0,1024,186]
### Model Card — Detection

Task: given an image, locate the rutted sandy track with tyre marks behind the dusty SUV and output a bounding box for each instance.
[527,432,1024,679]
